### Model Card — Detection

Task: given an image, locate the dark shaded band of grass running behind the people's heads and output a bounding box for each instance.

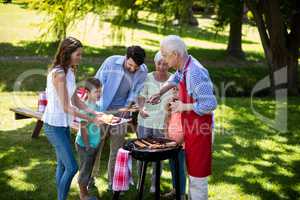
[0,40,267,96]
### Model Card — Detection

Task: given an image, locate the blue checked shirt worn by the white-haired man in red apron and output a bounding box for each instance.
[168,56,217,115]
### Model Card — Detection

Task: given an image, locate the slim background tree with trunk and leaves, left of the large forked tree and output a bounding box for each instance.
[215,0,245,58]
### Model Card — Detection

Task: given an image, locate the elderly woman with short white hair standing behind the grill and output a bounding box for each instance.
[137,52,172,192]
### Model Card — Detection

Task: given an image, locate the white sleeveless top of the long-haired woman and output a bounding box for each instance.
[42,67,76,127]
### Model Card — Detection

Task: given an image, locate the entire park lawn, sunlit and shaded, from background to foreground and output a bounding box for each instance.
[0,1,300,200]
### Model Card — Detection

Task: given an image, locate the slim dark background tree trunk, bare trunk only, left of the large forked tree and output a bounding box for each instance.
[227,0,245,58]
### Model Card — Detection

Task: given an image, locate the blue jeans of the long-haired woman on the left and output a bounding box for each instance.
[44,123,78,200]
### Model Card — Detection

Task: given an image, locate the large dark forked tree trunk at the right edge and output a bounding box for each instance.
[246,0,300,95]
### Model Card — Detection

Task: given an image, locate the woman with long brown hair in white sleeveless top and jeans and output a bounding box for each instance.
[42,37,101,200]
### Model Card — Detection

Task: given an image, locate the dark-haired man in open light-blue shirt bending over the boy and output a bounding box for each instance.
[90,46,148,190]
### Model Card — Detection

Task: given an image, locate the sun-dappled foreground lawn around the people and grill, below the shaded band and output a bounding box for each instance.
[0,92,300,200]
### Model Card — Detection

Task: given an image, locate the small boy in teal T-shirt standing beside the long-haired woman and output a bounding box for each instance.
[75,78,102,200]
